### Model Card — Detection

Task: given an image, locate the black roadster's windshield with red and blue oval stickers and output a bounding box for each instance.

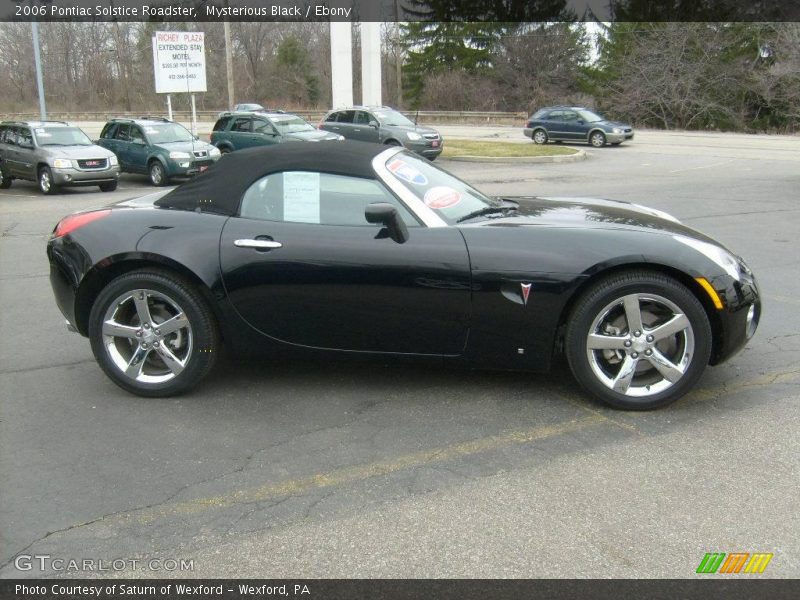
[386,152,502,225]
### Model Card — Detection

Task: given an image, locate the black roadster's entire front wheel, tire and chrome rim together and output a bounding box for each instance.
[565,270,712,410]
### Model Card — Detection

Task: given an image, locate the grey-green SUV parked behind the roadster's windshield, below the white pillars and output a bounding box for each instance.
[319,106,444,160]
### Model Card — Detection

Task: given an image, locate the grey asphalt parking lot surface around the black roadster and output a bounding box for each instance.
[0,128,800,578]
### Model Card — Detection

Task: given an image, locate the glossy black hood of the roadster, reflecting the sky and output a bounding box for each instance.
[476,196,718,244]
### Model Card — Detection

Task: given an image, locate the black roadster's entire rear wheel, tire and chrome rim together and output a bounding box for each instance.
[89,269,220,397]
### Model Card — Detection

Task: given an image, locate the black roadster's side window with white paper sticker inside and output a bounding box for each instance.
[239,171,419,227]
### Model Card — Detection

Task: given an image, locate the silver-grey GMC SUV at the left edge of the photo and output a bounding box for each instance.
[0,121,119,194]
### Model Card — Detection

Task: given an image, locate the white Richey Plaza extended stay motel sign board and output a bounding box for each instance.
[153,31,206,94]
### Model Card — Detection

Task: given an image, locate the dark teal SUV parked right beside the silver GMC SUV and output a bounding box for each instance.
[97,117,220,185]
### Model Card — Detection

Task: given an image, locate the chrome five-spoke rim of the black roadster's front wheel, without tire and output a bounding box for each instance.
[586,293,695,398]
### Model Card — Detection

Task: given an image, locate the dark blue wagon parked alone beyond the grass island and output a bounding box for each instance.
[523,106,633,148]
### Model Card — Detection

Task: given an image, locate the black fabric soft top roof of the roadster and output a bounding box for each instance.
[155,140,386,215]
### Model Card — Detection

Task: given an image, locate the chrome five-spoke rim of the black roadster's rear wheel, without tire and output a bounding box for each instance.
[102,289,193,383]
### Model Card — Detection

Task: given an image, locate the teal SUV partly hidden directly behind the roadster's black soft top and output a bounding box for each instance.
[211,112,344,154]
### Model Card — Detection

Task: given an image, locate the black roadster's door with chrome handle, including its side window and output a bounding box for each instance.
[220,172,471,355]
